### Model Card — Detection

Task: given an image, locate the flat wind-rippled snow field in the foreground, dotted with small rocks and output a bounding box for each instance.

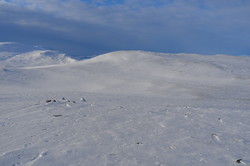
[0,94,250,165]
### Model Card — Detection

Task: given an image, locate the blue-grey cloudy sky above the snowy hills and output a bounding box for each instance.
[0,0,250,57]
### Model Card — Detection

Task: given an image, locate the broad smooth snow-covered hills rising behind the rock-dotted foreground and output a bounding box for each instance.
[0,51,250,98]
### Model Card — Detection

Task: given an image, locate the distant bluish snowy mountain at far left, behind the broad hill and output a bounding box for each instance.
[0,42,75,67]
